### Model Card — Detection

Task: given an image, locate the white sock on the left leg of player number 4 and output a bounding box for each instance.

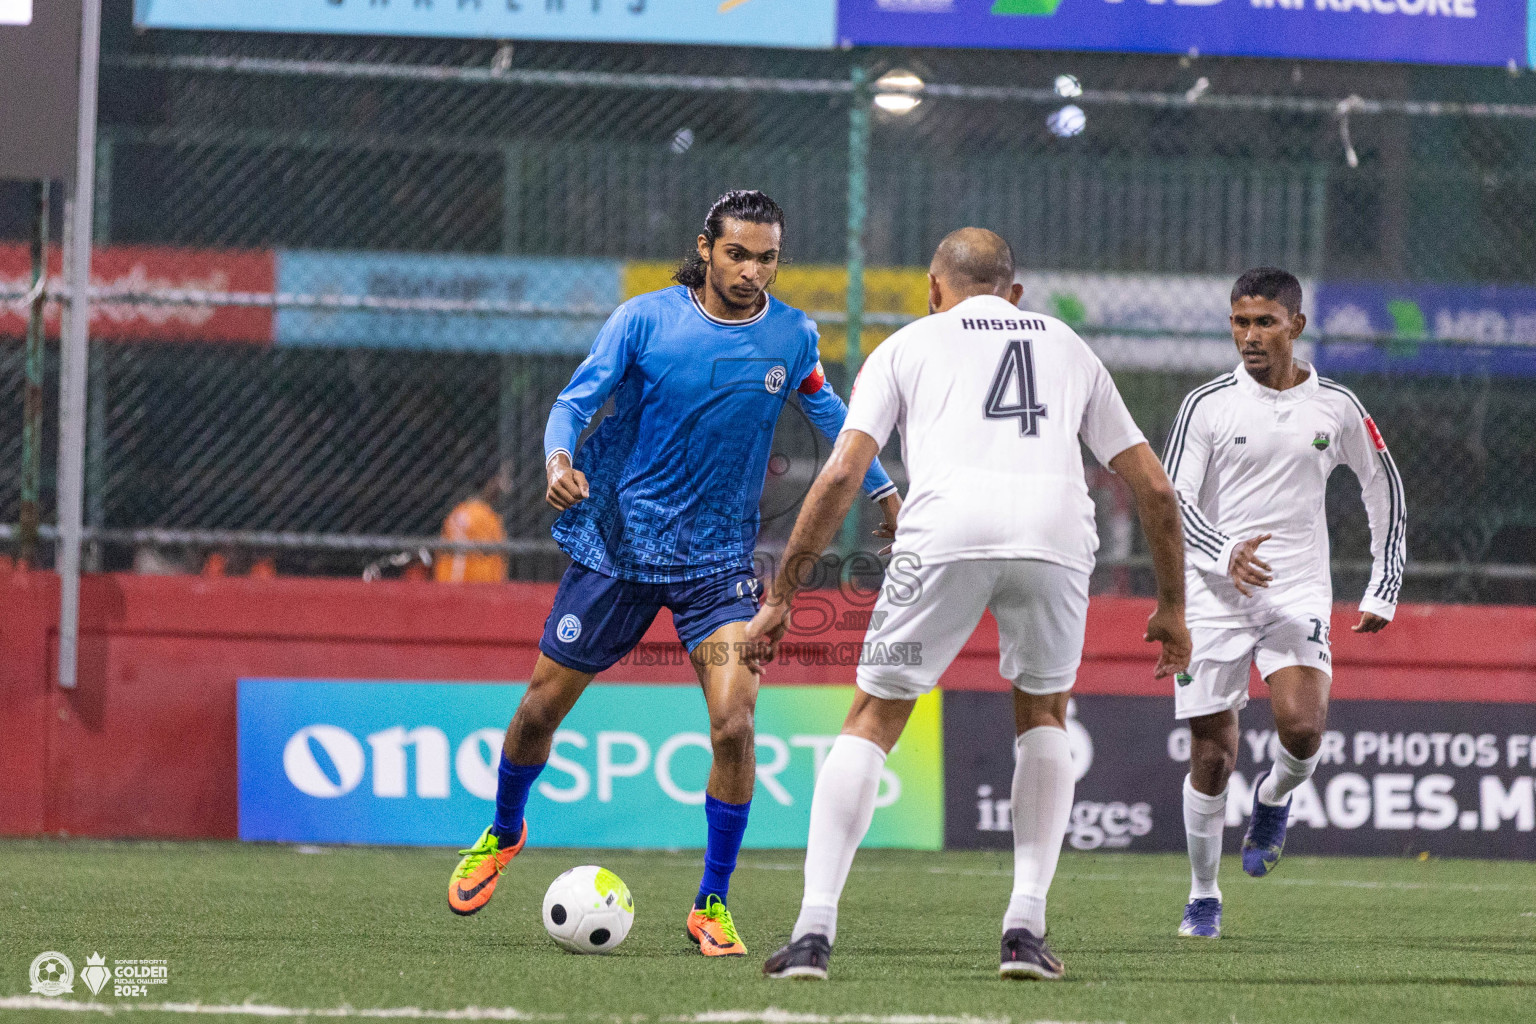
[790,735,885,943]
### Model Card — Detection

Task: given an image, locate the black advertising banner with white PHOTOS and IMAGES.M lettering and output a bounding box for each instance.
[945,692,1536,858]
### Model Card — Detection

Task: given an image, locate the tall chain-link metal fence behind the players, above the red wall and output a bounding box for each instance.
[0,14,1536,600]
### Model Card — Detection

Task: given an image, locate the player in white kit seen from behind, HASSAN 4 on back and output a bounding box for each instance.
[746,229,1189,978]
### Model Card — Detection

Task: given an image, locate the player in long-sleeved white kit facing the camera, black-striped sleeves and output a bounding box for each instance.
[1163,267,1407,938]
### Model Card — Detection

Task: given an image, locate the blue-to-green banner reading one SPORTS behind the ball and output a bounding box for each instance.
[237,679,943,849]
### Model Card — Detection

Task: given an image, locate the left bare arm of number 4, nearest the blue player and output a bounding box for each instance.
[746,430,878,671]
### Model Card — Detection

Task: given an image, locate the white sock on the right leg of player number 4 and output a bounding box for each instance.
[1003,726,1077,935]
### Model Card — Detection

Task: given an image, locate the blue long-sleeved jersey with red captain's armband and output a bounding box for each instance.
[544,286,895,583]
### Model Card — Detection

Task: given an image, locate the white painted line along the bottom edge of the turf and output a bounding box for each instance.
[0,995,1123,1024]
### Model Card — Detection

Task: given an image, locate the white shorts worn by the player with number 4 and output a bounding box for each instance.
[859,559,1087,700]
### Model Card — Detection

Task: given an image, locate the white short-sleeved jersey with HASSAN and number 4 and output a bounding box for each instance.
[843,295,1144,573]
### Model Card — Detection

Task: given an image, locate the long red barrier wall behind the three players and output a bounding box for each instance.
[0,573,1536,838]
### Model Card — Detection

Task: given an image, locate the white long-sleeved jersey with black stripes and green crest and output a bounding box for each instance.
[1163,361,1407,626]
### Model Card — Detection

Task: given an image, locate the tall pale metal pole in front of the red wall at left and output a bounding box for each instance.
[55,0,101,689]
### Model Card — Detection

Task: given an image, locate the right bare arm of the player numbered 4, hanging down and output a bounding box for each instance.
[1109,442,1192,679]
